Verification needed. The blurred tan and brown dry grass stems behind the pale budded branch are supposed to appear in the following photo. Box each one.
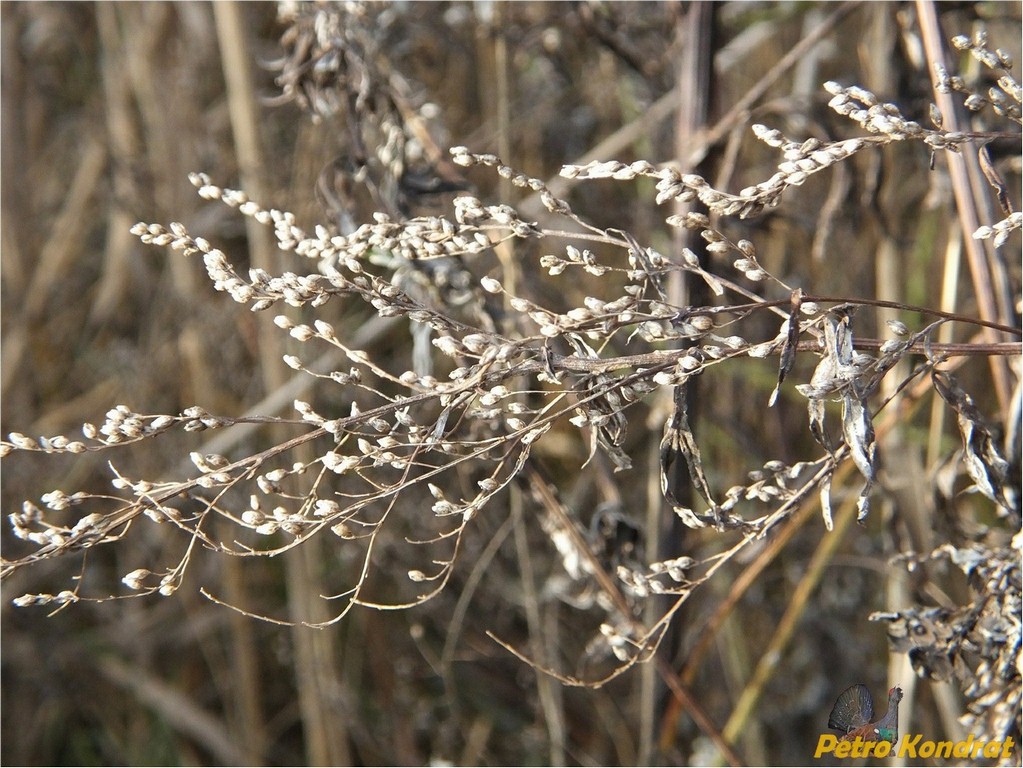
[0,2,1020,765]
